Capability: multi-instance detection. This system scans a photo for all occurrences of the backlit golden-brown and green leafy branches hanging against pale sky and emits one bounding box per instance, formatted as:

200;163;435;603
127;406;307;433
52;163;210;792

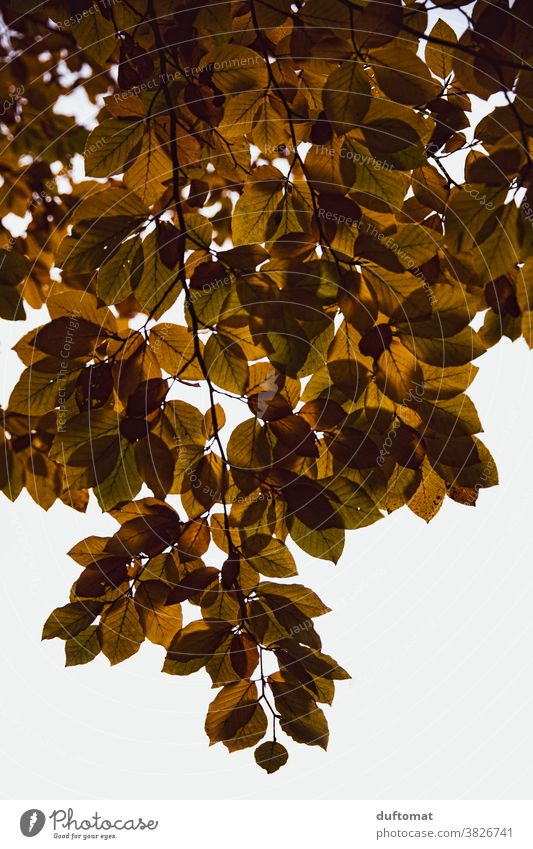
0;0;533;773
